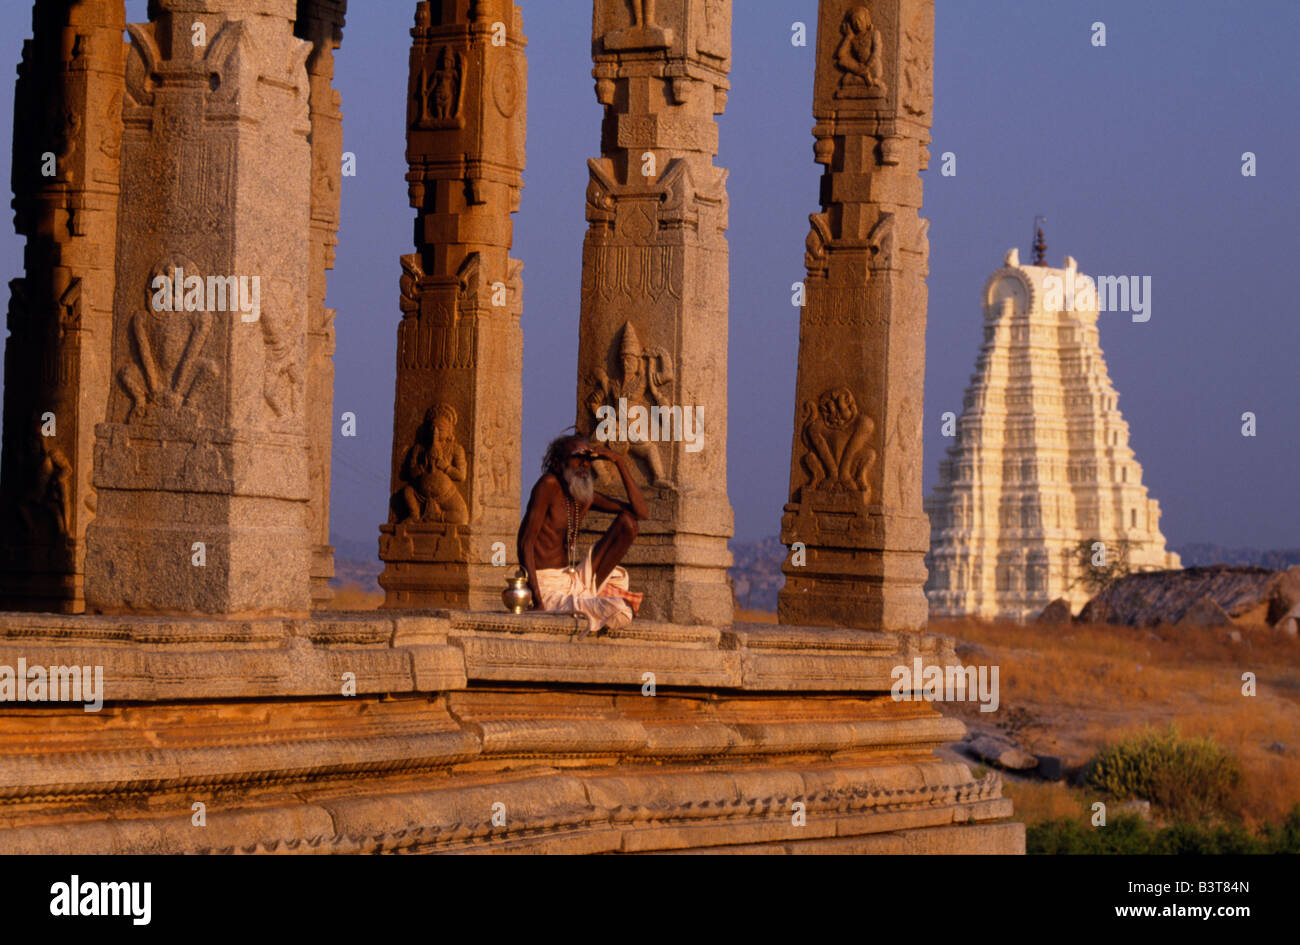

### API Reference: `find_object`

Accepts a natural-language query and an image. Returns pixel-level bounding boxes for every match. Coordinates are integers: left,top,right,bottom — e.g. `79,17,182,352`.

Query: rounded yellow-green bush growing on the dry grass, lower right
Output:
1084,725,1242,820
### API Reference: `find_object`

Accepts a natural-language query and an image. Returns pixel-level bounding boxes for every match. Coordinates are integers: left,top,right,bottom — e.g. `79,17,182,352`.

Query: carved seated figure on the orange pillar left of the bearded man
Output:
391,403,469,525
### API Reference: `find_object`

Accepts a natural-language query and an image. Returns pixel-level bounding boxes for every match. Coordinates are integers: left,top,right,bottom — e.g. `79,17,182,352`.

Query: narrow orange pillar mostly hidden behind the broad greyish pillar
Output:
295,0,347,607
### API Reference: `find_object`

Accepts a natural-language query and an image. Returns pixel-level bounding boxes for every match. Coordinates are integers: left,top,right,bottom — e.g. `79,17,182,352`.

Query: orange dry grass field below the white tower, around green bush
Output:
931,620,1300,825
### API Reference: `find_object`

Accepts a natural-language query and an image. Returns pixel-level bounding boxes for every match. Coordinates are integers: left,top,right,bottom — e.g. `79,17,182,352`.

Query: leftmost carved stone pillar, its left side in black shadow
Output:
0,0,126,612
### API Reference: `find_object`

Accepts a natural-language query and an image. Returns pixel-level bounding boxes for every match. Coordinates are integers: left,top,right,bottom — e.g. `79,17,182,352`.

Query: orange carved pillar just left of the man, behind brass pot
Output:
380,0,527,610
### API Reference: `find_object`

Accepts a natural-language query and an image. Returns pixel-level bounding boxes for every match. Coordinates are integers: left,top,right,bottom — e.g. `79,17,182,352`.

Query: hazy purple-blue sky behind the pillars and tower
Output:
0,0,1300,547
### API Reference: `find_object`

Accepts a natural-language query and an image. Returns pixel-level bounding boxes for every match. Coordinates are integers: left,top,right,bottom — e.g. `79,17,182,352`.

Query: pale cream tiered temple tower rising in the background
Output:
926,250,1180,617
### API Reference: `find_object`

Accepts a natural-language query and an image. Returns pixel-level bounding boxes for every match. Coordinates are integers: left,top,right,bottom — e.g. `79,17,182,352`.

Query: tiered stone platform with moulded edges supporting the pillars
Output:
0,611,1024,853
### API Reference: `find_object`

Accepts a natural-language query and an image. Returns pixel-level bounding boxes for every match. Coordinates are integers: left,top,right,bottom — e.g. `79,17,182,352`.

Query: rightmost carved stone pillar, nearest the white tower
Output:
779,0,935,630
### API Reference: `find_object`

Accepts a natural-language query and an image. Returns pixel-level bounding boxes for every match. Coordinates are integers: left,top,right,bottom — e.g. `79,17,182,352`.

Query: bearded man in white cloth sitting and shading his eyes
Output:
519,435,650,632
